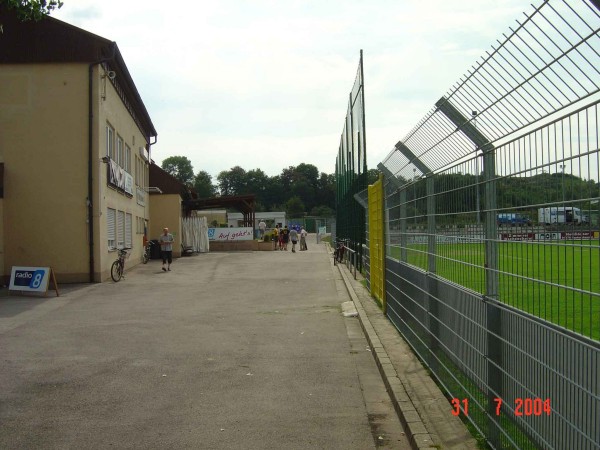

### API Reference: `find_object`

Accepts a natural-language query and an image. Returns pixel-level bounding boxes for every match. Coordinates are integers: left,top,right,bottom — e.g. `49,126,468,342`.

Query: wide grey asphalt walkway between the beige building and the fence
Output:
0,238,478,449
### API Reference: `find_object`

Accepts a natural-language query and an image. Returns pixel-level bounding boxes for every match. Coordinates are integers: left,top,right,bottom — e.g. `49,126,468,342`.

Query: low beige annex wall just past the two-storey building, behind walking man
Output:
148,194,182,258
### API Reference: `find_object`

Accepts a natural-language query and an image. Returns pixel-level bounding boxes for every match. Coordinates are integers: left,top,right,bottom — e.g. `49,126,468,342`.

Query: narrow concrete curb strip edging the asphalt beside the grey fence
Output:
338,258,439,450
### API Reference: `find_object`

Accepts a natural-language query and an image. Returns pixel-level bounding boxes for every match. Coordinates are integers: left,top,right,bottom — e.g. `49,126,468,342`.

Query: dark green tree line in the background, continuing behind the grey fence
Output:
162,156,600,222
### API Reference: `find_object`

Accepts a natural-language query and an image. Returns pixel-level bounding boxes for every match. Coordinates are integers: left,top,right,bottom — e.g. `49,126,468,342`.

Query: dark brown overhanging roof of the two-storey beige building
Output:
0,5,157,142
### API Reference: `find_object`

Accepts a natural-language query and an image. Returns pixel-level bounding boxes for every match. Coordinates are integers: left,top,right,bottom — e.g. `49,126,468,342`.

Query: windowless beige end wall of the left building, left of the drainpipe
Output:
0,64,88,282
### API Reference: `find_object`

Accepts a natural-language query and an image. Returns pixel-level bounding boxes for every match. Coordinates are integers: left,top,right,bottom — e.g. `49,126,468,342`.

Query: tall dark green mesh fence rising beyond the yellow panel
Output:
335,50,367,268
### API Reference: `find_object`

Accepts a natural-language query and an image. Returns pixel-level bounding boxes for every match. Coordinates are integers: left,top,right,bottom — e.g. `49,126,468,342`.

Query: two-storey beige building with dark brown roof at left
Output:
0,7,157,284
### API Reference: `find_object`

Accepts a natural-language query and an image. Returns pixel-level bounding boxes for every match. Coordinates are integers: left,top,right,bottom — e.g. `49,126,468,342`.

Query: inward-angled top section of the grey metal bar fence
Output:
383,0,600,180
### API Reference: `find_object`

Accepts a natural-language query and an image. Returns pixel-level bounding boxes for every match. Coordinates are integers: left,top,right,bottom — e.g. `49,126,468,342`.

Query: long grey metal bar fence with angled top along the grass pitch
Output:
360,0,600,449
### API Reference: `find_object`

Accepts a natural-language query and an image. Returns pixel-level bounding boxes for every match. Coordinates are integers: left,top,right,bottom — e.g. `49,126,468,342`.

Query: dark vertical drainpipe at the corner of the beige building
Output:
87,42,117,283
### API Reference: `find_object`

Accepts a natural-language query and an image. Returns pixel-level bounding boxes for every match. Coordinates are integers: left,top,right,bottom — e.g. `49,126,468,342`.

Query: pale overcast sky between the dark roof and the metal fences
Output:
52,0,528,182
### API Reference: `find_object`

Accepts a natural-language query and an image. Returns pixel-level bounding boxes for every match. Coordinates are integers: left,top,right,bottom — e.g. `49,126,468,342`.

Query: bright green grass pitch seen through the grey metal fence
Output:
391,239,600,340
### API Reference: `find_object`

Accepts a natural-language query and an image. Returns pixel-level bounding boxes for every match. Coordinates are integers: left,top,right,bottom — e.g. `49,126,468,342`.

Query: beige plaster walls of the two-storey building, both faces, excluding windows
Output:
0,63,149,283
